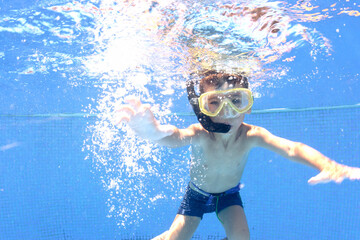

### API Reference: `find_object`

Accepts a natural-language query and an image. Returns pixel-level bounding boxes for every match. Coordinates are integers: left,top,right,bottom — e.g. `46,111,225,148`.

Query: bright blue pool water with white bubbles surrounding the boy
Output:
0,0,360,240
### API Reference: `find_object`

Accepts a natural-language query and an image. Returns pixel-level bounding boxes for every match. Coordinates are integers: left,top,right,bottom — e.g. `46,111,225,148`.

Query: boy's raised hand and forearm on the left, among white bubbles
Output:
117,97,174,141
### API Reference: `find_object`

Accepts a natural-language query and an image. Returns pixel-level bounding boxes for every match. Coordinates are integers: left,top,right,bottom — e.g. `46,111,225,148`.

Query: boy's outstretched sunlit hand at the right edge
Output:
308,163,360,185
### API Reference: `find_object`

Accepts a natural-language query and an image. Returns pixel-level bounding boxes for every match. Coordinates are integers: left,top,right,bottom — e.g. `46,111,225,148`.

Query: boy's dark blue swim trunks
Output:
178,182,243,219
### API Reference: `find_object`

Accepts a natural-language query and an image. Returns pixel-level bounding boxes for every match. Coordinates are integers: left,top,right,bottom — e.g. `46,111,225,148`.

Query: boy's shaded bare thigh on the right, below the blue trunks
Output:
218,205,250,240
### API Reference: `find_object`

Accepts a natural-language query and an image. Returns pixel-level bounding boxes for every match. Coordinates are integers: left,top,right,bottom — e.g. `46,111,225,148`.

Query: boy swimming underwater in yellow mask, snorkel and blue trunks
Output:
120,71,360,240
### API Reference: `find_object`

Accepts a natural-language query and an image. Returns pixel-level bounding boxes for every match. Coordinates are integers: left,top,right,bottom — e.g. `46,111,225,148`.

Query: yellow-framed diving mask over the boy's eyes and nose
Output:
199,88,253,118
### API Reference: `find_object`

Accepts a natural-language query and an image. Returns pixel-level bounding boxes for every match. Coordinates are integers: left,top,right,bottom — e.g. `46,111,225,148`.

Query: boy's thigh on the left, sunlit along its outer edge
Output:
166,214,201,240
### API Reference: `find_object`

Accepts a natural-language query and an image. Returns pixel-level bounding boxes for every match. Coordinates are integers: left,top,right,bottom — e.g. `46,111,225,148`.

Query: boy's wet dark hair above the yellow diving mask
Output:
199,70,249,94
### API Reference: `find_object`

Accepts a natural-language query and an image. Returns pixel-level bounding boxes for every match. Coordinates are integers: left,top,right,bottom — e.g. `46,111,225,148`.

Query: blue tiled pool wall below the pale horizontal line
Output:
0,107,360,240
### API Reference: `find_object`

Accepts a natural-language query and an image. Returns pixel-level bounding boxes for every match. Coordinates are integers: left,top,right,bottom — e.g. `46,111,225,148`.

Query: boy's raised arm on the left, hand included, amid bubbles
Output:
118,97,195,147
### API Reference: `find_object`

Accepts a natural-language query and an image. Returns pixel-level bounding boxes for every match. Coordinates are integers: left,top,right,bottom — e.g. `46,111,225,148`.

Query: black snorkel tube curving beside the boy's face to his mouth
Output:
186,80,231,133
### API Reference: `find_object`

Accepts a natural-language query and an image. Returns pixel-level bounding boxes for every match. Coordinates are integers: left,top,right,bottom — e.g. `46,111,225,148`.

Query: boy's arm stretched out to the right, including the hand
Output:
250,127,360,184
